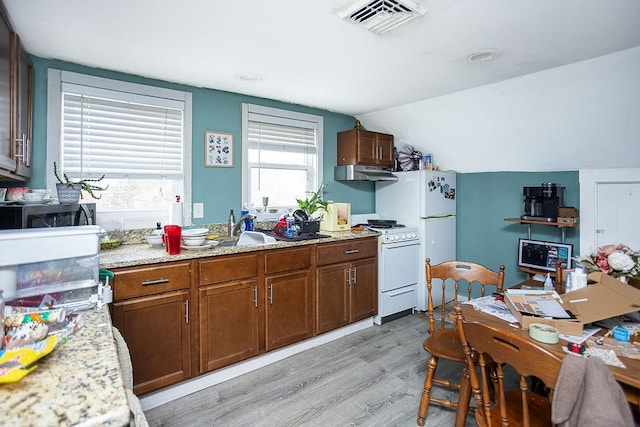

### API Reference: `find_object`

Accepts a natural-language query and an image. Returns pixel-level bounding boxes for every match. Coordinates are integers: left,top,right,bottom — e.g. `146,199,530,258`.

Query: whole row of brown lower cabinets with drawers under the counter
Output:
111,238,378,395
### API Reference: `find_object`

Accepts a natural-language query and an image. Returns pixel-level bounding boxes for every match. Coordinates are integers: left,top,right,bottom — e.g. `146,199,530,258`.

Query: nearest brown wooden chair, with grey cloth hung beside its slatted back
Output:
454,306,562,427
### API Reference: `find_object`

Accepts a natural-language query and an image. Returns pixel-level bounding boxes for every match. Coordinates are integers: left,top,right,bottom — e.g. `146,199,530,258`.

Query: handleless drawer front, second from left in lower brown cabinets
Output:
198,254,258,285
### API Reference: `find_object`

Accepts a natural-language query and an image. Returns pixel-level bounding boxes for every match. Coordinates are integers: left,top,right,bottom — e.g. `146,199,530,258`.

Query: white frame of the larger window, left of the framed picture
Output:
46,69,192,229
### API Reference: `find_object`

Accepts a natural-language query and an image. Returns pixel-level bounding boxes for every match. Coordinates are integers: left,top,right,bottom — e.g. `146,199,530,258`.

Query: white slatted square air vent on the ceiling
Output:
337,0,427,35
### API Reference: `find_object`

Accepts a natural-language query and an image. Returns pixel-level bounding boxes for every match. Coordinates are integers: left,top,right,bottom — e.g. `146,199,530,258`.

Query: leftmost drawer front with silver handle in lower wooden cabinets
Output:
114,262,191,301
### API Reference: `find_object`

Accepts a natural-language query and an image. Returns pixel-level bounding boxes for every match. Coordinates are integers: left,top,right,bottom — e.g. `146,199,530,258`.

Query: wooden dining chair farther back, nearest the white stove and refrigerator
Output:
417,258,504,426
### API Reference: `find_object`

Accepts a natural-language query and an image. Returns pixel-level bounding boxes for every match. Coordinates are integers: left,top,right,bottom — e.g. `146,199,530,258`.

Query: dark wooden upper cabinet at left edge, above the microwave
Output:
0,3,33,181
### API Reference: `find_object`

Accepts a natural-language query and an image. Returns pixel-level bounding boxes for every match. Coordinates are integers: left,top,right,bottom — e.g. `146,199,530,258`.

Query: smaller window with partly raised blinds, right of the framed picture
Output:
243,104,322,213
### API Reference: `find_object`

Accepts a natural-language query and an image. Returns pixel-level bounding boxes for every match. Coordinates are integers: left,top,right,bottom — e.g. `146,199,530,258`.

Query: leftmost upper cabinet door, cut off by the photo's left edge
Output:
0,7,16,174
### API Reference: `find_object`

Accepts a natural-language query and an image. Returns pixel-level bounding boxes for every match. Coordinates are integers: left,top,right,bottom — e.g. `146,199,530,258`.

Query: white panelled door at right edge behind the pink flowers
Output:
580,169,640,256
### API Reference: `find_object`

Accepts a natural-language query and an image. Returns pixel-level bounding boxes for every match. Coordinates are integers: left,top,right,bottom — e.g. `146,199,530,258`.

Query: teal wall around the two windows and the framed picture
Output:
30,57,375,224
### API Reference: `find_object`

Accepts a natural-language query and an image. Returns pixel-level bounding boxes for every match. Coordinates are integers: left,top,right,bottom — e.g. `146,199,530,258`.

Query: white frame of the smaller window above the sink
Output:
241,103,324,220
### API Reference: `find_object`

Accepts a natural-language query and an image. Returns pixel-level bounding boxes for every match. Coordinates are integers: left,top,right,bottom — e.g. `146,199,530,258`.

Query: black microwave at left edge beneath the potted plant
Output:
0,203,96,230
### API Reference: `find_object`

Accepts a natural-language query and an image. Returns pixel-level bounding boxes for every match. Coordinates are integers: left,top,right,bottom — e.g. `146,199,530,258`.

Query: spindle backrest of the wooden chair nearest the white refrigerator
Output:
426,258,504,332
